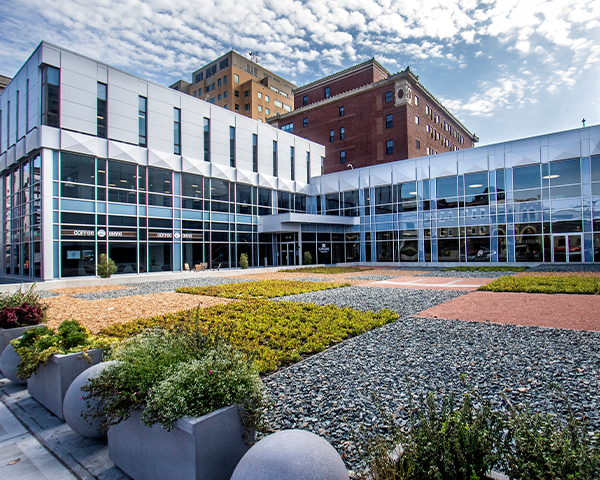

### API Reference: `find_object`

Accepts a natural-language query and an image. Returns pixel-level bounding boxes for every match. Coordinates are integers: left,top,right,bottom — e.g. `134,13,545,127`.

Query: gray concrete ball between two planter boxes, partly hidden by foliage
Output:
63,362,117,438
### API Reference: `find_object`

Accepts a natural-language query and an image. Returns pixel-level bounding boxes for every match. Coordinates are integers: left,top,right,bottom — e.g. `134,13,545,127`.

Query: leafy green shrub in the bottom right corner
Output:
502,388,600,480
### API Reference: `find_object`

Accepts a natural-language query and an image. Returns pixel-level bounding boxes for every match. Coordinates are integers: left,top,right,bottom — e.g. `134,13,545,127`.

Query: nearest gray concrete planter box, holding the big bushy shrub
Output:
108,405,254,480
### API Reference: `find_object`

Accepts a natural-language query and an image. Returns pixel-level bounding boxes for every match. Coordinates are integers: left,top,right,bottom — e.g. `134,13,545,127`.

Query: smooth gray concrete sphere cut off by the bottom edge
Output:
231,430,349,480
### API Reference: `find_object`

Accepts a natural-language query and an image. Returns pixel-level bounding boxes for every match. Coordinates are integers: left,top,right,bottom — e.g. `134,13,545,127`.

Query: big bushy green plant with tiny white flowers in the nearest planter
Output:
83,329,262,430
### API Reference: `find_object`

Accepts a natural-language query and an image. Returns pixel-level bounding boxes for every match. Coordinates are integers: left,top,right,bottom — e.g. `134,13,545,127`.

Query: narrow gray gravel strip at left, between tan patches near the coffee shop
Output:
71,277,254,300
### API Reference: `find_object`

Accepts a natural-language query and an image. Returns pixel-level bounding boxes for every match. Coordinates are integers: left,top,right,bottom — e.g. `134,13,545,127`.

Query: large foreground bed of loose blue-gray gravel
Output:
264,317,600,471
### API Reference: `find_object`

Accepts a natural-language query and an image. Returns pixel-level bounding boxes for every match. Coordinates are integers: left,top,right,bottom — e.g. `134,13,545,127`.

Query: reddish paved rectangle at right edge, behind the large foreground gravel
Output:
414,292,600,331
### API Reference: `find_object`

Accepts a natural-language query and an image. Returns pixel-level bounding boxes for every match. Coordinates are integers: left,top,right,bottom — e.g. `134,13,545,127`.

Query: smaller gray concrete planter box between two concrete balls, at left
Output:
27,348,102,420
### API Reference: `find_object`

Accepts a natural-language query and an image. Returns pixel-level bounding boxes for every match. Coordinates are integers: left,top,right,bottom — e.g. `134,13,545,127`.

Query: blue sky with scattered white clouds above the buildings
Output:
0,0,600,145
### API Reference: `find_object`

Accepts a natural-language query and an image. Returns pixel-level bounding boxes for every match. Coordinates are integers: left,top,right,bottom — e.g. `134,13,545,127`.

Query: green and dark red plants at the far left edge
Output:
0,284,48,328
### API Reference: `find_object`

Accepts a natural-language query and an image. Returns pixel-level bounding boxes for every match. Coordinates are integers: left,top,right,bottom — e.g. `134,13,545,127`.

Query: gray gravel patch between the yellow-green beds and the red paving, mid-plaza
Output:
273,287,467,316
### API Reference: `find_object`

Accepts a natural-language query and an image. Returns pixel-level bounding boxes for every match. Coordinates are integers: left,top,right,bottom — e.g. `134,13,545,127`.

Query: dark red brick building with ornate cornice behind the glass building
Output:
267,59,479,173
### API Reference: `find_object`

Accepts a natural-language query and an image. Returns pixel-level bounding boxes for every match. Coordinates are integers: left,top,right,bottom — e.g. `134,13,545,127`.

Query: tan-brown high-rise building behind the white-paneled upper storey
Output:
171,50,296,122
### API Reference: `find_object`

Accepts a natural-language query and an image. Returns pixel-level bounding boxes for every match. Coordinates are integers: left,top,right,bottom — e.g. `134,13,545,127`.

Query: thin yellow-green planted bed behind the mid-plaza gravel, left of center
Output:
176,280,350,300
